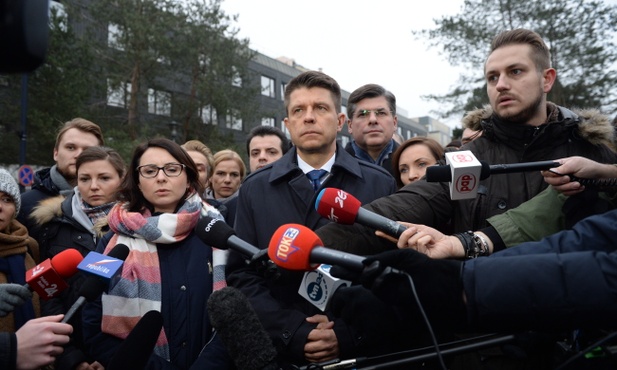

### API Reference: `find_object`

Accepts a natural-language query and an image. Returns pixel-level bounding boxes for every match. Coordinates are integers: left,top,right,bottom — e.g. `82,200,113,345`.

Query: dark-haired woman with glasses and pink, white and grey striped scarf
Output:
83,139,231,369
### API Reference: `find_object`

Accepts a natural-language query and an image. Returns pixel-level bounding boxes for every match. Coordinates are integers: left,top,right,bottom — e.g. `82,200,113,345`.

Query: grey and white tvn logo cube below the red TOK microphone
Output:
298,264,351,311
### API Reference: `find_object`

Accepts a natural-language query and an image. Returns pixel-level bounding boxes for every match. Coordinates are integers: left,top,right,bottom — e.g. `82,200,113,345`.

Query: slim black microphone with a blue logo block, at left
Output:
61,244,129,322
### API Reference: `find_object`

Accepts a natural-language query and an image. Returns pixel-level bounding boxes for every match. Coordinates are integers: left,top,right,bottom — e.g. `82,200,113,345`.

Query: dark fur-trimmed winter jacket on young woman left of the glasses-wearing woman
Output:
32,193,102,370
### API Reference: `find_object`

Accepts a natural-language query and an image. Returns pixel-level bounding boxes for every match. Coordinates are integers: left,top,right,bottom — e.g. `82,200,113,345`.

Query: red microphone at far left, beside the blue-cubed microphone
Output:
24,248,84,300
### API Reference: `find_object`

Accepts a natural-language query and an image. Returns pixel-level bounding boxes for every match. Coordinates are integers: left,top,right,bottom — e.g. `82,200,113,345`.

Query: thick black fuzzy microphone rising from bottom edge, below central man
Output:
207,287,279,370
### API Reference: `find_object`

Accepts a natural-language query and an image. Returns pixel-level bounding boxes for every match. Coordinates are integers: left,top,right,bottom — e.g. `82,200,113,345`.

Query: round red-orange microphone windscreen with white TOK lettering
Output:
268,224,323,271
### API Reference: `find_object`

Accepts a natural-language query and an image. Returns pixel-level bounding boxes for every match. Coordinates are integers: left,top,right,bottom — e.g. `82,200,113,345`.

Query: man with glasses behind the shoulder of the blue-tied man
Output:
345,84,399,176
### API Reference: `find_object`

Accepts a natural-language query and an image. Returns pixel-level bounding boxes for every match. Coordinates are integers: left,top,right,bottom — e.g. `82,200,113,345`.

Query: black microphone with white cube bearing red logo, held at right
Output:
426,150,561,200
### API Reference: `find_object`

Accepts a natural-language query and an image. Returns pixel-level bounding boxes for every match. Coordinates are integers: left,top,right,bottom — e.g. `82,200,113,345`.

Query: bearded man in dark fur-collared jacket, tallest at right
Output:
317,29,617,369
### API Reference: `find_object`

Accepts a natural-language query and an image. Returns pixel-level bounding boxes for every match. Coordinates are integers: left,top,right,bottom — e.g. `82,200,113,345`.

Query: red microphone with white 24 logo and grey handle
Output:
315,188,407,239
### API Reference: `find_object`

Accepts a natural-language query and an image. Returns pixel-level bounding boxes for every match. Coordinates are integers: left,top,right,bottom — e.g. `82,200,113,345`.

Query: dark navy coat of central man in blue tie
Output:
227,145,396,363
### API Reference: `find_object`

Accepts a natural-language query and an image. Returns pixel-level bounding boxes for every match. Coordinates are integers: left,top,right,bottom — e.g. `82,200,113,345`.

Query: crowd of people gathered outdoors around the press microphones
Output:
0,29,617,370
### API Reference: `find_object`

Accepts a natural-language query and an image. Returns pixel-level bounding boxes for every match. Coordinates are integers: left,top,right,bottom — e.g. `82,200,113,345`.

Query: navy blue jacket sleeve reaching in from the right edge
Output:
463,210,617,330
